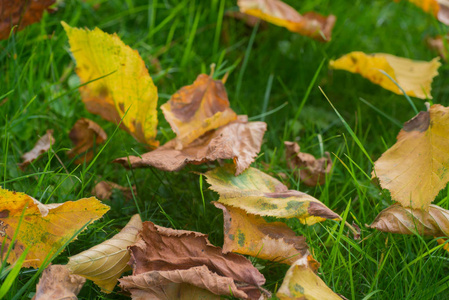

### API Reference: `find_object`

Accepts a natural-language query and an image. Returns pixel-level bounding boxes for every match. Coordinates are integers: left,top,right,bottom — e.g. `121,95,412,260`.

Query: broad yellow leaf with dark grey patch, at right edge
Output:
372,104,449,209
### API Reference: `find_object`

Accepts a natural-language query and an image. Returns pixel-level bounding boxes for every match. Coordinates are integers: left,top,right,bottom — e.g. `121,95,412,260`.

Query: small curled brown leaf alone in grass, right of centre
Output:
284,142,332,186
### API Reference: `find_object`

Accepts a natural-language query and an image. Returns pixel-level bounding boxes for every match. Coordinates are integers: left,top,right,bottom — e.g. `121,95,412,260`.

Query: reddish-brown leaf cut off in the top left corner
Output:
0,0,56,40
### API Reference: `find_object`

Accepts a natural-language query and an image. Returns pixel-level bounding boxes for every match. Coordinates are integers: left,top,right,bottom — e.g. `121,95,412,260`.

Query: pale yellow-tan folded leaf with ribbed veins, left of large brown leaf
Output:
67,215,142,293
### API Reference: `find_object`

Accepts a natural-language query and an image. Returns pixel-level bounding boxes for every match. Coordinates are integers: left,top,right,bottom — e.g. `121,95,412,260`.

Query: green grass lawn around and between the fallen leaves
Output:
0,0,449,300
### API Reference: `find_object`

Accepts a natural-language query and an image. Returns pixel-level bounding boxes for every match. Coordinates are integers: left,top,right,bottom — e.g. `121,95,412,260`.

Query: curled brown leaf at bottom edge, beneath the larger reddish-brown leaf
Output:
119,266,248,300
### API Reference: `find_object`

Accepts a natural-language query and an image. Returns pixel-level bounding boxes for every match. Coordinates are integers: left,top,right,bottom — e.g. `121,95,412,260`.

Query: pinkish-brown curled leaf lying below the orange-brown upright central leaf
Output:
114,116,267,175
